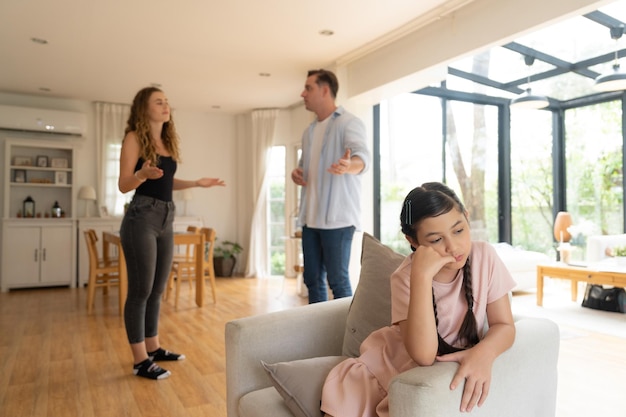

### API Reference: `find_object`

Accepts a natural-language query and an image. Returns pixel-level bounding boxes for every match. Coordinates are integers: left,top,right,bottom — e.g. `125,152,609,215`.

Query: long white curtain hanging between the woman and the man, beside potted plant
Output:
246,109,279,278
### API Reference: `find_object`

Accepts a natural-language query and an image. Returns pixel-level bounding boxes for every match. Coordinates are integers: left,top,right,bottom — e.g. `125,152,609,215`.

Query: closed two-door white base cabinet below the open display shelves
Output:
2,219,76,292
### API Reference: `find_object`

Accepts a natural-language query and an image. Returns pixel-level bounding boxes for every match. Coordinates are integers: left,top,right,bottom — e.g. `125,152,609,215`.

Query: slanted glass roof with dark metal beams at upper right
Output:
436,0,626,104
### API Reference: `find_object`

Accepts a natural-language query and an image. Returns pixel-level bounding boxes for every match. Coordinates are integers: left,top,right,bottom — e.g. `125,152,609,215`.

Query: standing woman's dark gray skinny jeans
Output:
120,195,175,344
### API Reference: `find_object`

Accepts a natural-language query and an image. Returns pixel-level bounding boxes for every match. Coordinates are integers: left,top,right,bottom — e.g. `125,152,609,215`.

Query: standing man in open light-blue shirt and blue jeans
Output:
291,69,370,304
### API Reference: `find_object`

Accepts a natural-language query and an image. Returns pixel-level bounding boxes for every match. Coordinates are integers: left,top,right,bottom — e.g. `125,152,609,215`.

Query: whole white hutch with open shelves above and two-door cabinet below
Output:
1,139,76,291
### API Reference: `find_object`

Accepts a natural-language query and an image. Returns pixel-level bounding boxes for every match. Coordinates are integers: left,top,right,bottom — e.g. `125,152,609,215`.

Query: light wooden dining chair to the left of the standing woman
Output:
84,229,119,314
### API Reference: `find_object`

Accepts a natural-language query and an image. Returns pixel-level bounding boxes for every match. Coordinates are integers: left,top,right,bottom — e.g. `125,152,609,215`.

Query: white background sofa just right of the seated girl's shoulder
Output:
492,242,554,292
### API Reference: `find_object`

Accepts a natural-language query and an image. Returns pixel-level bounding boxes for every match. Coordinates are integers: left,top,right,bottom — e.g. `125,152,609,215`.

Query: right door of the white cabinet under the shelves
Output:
40,226,74,285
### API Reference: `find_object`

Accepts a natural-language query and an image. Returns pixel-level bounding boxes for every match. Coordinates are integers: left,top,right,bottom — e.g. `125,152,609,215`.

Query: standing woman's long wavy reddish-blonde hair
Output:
124,87,180,166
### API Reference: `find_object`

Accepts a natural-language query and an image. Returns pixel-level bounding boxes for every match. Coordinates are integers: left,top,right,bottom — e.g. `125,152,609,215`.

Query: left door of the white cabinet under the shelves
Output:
2,227,41,291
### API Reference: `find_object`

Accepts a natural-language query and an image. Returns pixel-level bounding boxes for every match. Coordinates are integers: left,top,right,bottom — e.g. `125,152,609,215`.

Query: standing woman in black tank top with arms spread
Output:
118,87,225,379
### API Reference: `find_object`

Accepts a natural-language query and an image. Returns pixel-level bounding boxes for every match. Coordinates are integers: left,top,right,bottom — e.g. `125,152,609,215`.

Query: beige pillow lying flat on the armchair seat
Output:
261,356,346,417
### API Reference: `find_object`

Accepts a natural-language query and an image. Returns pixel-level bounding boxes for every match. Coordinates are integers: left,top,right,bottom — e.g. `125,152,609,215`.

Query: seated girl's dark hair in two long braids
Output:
400,182,478,355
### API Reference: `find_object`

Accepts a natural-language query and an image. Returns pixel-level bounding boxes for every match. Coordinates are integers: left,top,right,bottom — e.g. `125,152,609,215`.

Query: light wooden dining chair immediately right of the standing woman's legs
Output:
165,230,205,308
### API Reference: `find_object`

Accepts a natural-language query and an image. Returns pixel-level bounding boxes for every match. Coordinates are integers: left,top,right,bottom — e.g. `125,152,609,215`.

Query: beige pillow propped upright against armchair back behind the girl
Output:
342,233,405,358
